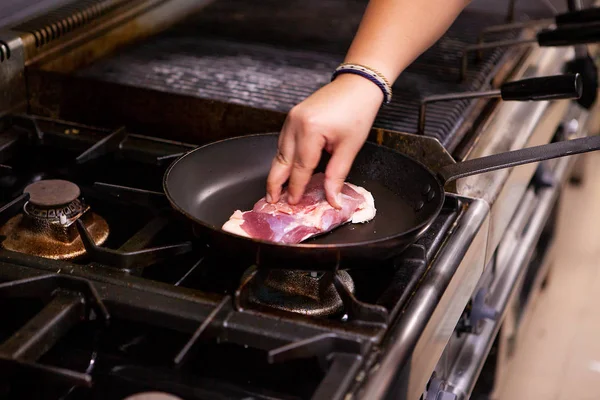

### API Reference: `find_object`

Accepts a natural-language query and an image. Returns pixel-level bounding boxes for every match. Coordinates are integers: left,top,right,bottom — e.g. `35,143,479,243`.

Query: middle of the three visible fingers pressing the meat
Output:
288,132,325,204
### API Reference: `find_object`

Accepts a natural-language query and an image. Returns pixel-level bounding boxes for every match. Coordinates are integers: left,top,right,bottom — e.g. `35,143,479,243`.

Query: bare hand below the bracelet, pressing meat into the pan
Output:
267,74,383,208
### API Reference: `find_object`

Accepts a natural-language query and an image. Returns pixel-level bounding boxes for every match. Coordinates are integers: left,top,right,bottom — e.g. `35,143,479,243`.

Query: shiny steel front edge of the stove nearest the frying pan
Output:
355,195,490,399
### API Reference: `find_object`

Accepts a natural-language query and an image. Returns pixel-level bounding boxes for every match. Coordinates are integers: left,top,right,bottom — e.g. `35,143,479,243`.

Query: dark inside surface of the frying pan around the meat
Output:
165,134,443,245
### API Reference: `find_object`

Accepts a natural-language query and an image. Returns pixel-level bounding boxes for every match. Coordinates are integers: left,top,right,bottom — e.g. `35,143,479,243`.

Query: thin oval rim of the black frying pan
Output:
163,132,446,250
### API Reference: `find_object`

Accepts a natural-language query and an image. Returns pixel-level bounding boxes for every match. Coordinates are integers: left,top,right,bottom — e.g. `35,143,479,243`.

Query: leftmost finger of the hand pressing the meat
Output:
266,121,295,203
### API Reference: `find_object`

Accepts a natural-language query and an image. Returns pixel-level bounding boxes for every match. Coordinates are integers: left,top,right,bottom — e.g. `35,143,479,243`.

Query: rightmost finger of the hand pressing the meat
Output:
325,142,360,209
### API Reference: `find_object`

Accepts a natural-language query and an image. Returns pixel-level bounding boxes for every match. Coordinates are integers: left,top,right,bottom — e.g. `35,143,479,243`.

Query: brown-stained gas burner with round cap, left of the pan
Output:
0,180,109,260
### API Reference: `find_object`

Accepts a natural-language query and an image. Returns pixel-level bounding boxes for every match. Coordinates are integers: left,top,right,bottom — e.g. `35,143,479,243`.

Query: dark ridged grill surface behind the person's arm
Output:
79,0,560,147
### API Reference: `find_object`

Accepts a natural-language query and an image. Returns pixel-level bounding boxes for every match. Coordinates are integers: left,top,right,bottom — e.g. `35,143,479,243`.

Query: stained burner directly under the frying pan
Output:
242,268,354,317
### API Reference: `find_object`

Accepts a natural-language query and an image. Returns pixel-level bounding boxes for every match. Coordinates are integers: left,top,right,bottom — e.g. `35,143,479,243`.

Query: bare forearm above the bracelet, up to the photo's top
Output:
345,0,469,82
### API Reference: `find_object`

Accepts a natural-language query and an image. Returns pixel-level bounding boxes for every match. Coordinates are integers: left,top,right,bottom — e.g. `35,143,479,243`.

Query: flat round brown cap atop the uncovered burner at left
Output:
23,179,81,207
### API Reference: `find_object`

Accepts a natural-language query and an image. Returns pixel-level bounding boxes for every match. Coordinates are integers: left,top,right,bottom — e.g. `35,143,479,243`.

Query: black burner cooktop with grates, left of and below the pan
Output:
0,116,467,399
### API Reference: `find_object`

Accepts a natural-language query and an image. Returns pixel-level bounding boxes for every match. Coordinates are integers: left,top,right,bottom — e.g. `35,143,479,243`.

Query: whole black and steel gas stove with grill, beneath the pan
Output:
0,0,597,400
